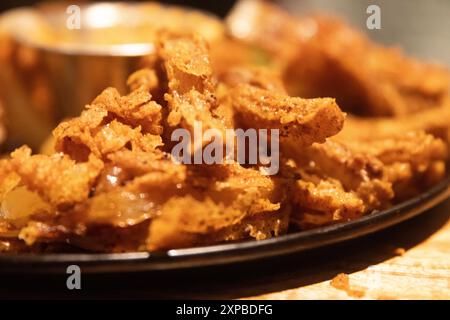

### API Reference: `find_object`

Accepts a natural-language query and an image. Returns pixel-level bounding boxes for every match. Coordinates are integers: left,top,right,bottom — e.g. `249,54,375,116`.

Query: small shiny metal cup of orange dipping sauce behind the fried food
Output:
0,2,221,149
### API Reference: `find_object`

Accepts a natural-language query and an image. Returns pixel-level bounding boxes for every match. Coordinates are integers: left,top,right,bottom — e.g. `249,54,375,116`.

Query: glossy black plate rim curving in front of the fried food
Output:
0,177,450,274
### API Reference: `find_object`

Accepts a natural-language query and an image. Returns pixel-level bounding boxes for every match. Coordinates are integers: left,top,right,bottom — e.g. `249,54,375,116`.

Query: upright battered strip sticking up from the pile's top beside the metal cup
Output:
157,35,229,141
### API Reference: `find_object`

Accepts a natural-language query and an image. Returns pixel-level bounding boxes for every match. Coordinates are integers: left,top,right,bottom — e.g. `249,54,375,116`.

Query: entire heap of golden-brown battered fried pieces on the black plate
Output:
0,12,450,252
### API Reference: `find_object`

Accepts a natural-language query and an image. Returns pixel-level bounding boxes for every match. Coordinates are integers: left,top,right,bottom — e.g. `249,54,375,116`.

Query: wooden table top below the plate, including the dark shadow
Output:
0,201,450,299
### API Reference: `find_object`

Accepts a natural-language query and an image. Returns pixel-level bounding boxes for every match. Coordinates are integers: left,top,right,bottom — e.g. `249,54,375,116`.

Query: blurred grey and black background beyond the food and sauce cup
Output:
0,0,450,66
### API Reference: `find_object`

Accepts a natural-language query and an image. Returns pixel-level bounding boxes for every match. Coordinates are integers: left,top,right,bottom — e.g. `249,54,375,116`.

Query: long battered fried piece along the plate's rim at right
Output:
292,132,448,228
